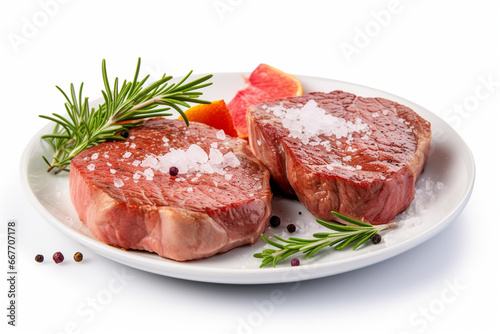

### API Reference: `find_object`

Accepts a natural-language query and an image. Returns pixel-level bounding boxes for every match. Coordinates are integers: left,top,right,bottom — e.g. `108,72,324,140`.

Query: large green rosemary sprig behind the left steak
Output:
39,58,212,174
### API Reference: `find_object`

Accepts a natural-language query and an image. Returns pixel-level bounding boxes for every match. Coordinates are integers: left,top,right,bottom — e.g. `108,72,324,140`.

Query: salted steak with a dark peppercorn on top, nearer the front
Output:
70,119,272,261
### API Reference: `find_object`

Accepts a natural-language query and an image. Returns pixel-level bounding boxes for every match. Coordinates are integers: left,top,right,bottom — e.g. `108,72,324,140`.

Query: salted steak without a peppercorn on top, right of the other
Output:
247,91,431,224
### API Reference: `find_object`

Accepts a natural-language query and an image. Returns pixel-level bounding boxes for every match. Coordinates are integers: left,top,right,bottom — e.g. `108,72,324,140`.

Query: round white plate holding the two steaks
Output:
21,73,475,284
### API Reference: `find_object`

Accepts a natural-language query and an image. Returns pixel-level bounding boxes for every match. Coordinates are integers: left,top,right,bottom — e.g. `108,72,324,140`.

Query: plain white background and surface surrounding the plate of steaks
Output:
0,0,500,334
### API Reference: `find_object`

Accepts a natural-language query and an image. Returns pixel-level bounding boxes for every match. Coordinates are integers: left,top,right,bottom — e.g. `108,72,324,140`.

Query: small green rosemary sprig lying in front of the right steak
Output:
253,211,397,268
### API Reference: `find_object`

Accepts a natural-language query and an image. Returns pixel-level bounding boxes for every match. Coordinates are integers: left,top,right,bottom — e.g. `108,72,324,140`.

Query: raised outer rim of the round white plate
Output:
19,72,476,284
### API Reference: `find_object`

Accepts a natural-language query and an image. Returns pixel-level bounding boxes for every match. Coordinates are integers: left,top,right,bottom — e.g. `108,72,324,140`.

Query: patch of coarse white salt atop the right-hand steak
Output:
266,100,371,145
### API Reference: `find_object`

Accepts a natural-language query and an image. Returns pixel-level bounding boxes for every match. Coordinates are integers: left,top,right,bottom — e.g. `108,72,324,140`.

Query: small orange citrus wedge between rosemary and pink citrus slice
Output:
179,100,238,137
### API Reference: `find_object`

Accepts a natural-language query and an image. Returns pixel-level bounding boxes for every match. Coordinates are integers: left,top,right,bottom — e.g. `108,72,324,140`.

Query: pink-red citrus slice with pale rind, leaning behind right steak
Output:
227,64,302,138
